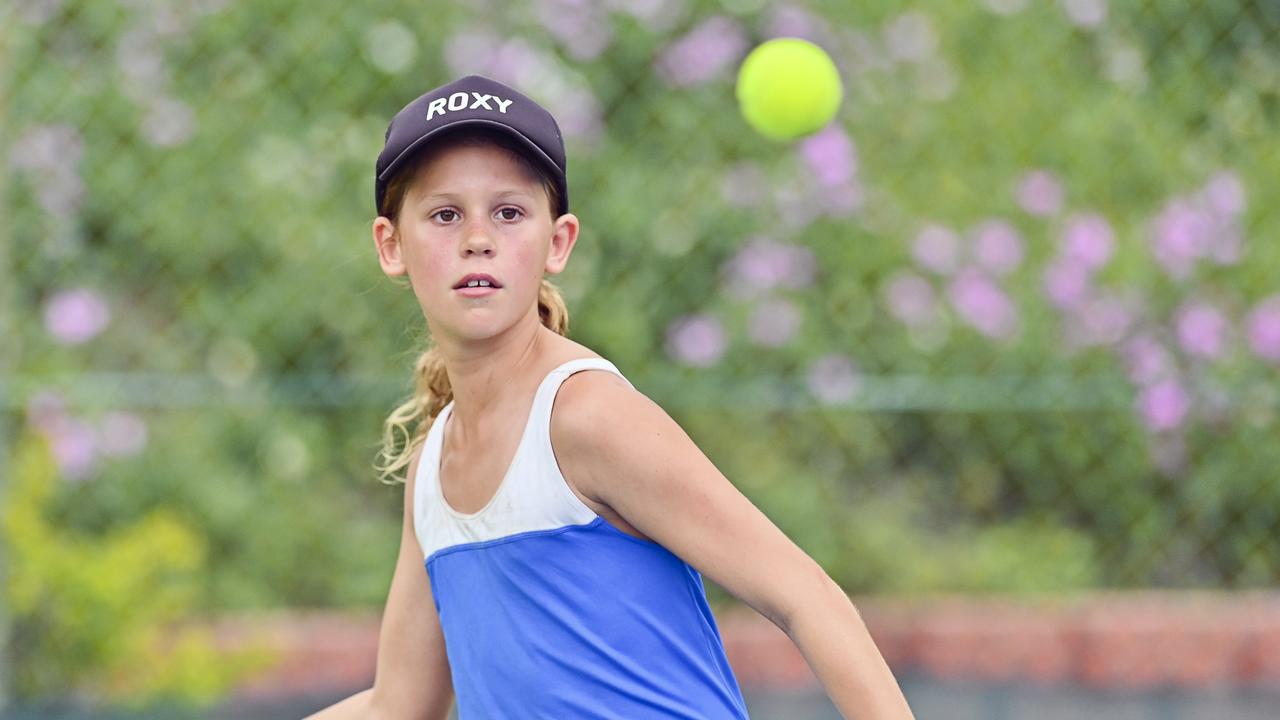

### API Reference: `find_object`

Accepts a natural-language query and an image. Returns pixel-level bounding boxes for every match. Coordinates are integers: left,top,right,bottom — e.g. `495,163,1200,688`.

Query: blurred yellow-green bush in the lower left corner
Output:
0,433,271,706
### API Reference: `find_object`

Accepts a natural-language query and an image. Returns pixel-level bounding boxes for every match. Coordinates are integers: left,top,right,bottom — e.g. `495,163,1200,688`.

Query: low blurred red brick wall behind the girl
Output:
202,592,1280,697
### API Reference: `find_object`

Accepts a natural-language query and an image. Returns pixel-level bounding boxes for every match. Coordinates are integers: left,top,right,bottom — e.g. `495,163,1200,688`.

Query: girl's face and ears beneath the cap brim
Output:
374,146,577,341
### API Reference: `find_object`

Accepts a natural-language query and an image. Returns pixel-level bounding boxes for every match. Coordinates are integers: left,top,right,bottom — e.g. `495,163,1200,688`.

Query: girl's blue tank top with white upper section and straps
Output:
413,357,748,720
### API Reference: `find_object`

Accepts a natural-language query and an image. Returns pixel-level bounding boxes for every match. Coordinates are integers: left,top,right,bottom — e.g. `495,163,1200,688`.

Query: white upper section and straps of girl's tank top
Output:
413,357,635,560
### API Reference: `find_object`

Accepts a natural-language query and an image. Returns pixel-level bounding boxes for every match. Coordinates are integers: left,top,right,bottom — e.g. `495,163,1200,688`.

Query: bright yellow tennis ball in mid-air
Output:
735,37,845,141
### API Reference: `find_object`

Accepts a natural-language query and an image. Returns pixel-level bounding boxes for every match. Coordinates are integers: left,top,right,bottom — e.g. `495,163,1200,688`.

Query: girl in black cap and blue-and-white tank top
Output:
305,76,911,720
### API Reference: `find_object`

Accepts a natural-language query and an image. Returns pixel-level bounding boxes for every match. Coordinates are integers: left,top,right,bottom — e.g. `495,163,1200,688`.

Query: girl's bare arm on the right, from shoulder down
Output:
552,372,914,720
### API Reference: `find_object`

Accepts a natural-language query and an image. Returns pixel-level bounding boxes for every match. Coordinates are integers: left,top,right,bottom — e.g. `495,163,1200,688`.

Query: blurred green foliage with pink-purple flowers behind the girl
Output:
0,0,1280,698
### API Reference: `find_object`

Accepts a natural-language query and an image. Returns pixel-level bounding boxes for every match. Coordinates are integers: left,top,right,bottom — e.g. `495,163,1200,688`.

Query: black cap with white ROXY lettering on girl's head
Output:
374,76,568,215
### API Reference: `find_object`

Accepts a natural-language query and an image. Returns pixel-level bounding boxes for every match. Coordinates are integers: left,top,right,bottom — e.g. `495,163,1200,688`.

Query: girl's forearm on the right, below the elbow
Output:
783,582,915,720
